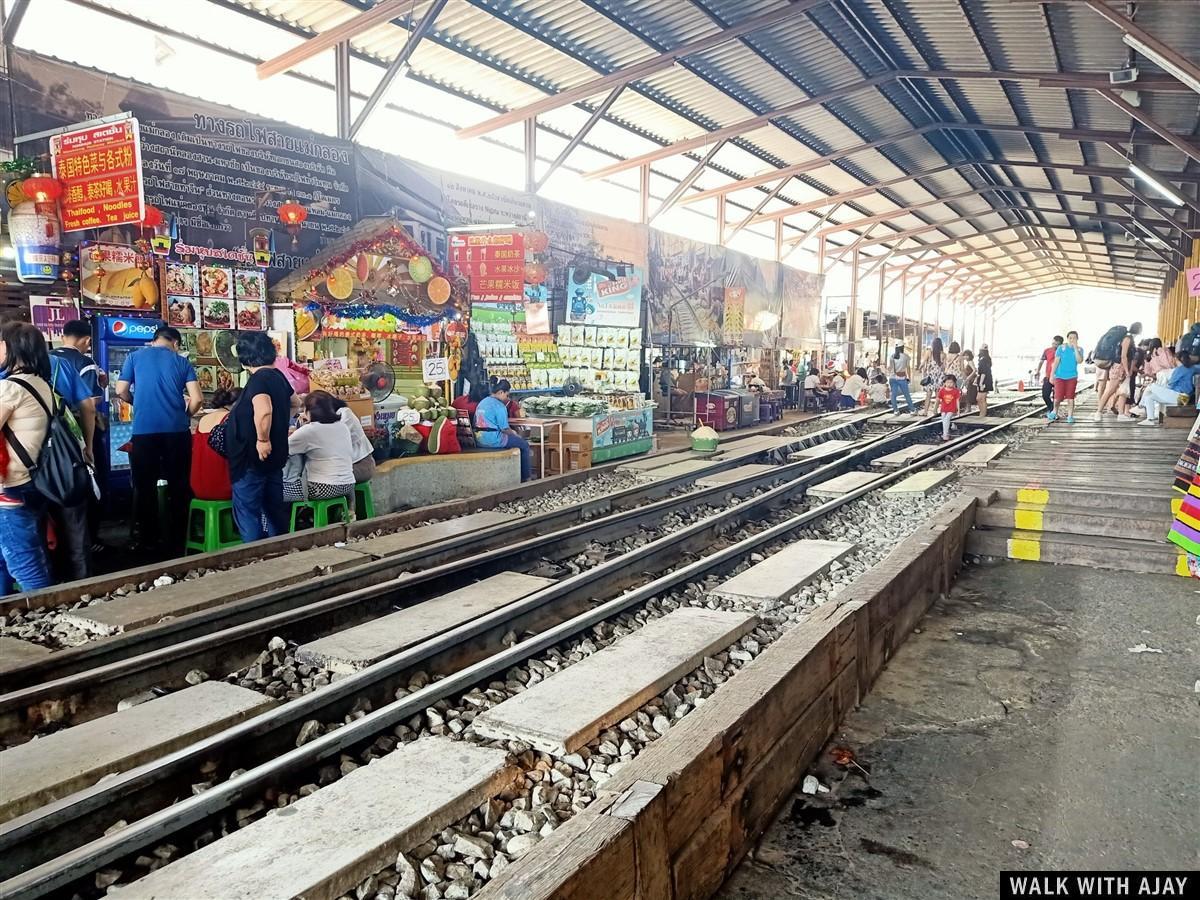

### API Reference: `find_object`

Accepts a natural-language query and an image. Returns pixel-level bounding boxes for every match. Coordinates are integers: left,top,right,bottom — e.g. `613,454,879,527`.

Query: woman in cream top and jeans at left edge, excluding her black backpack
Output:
0,322,53,596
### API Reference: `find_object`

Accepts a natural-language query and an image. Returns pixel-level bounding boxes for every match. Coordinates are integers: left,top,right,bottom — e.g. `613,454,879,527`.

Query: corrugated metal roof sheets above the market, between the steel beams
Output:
147,0,1200,292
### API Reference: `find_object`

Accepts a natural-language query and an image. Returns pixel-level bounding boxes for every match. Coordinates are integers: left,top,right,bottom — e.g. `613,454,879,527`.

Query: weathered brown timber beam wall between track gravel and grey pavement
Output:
478,492,986,900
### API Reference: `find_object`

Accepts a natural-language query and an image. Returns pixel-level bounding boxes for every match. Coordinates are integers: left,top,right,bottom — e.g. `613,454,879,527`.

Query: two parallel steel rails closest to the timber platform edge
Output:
0,409,1040,900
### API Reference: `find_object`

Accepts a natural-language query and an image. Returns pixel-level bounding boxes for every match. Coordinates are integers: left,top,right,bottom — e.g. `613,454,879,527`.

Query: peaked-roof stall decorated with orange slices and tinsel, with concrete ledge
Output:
270,211,520,512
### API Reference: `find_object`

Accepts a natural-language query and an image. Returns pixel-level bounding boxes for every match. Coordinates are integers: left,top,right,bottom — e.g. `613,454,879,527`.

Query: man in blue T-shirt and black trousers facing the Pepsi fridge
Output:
116,325,204,556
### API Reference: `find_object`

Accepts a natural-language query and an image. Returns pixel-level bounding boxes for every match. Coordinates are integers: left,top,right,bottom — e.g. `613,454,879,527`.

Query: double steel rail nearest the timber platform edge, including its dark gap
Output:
0,413,1034,896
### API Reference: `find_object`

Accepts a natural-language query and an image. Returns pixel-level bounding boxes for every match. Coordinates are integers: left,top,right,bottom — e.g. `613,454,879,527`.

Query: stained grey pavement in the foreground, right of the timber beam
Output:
719,563,1200,900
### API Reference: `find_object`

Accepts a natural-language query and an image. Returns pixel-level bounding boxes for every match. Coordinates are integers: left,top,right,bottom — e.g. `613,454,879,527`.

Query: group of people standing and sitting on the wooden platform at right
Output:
1034,322,1200,427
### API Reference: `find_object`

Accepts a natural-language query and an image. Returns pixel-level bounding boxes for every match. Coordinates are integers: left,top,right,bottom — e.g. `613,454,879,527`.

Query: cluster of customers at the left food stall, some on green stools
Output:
0,322,374,595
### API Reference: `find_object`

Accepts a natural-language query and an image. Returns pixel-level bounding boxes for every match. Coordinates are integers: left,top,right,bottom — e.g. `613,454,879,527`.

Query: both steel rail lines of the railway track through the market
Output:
0,398,1033,898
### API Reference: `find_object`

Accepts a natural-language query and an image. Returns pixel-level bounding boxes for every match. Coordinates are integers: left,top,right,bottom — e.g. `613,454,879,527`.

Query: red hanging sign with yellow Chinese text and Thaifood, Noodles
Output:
50,119,144,232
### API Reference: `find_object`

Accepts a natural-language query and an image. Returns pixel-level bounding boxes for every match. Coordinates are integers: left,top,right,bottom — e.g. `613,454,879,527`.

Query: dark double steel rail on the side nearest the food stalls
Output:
0,408,998,743
